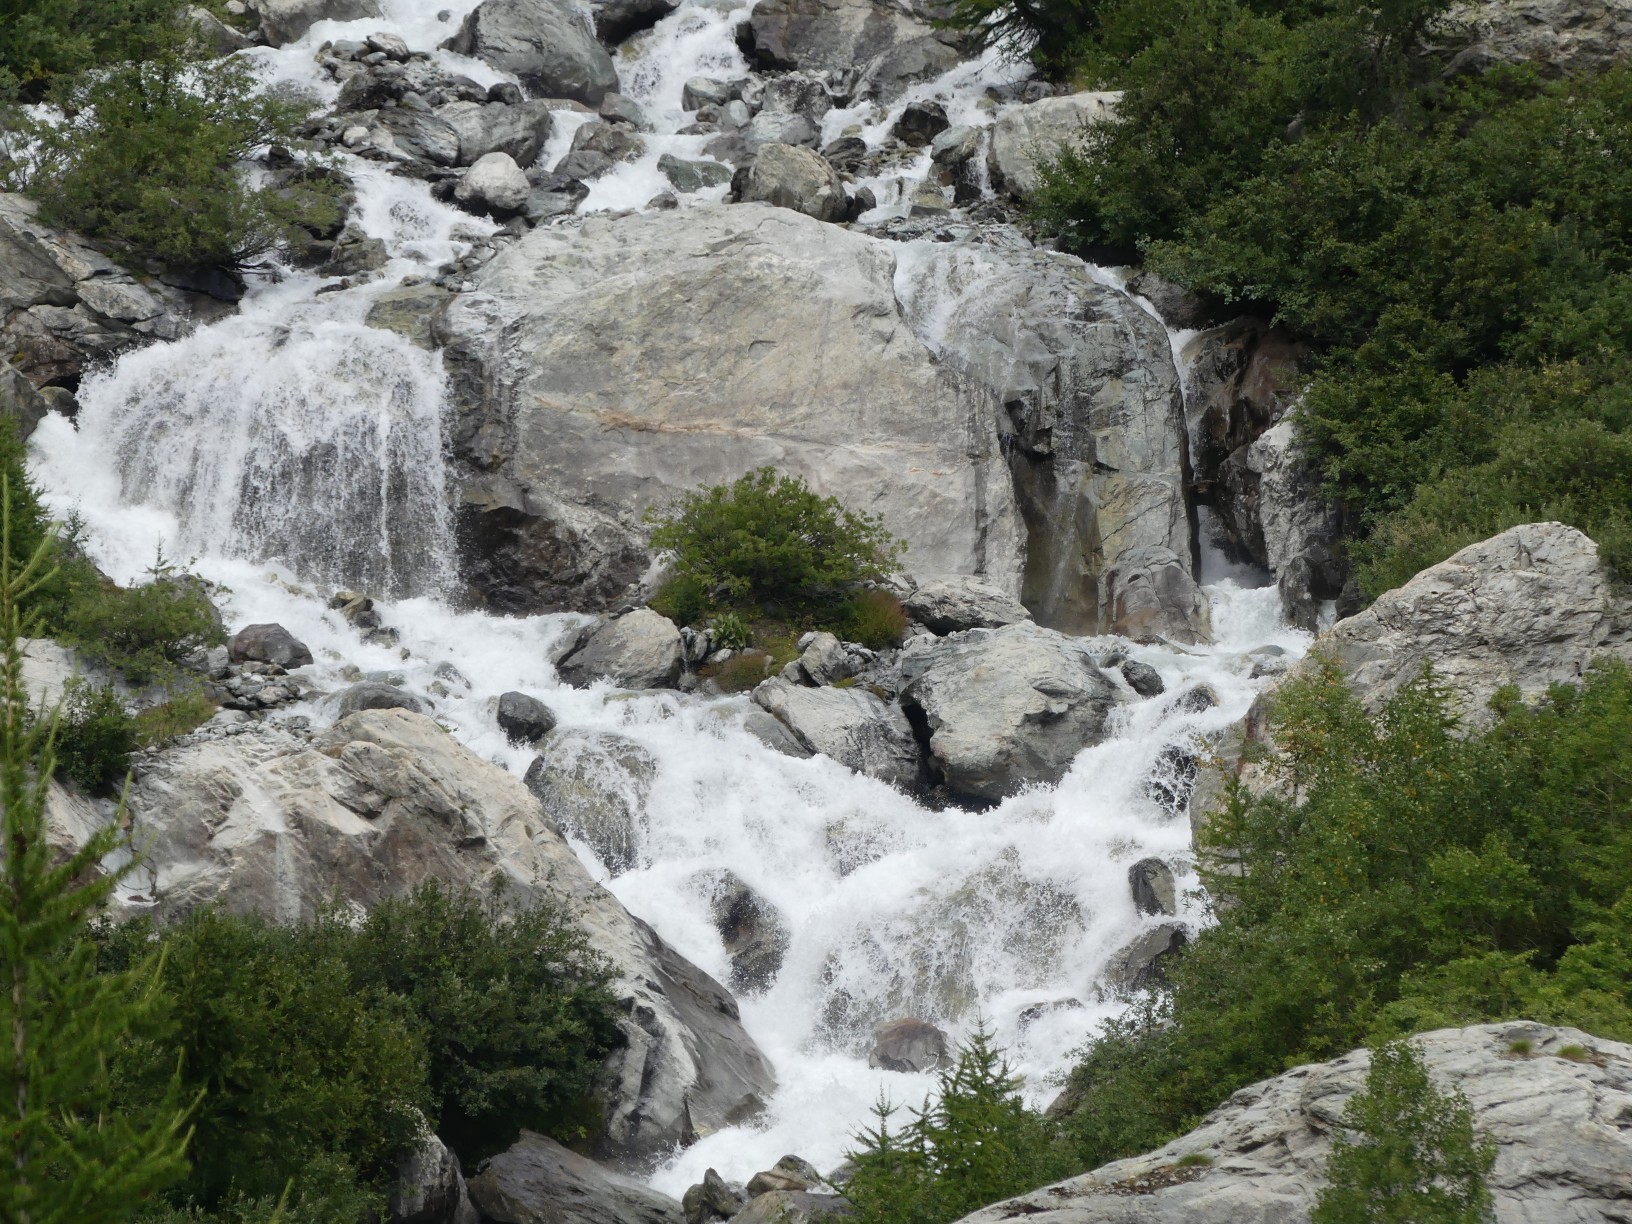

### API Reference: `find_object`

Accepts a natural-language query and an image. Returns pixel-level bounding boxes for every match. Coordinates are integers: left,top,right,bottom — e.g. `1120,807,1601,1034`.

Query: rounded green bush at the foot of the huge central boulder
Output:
651,467,906,620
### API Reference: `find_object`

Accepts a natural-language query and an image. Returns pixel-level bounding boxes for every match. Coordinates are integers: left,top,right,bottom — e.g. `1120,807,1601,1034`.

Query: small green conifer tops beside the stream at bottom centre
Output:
844,1027,1069,1224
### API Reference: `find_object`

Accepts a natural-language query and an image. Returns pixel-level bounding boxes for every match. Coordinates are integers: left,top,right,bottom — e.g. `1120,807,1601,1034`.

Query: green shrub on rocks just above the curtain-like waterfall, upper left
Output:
13,46,338,268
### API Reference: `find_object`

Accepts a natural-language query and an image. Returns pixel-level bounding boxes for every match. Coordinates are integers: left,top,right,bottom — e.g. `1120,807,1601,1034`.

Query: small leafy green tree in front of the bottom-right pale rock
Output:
1310,1041,1497,1224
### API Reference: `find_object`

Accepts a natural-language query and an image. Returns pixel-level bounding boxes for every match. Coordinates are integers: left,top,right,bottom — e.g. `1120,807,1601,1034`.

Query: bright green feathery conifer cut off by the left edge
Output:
0,489,188,1224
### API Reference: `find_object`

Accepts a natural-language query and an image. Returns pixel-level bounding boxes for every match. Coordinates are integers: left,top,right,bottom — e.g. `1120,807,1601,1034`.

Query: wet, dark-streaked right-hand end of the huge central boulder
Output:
898,242,1208,641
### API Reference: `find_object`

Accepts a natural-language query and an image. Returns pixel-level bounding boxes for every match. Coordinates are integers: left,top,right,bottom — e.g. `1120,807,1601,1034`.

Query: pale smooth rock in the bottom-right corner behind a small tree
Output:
963,1020,1632,1224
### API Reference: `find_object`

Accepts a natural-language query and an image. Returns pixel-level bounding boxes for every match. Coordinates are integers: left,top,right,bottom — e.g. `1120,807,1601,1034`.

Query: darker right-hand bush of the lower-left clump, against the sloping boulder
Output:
346,883,620,1162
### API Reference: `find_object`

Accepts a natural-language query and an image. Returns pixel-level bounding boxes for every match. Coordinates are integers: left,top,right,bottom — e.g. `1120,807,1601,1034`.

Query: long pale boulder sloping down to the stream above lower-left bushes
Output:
97,710,774,1160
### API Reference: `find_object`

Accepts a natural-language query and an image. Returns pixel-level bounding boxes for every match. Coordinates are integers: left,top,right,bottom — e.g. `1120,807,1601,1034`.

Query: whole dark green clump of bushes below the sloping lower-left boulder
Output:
98,885,619,1224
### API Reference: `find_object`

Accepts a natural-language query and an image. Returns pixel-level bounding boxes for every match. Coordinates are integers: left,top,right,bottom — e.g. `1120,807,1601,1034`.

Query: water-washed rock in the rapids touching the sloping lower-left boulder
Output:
524,730,658,875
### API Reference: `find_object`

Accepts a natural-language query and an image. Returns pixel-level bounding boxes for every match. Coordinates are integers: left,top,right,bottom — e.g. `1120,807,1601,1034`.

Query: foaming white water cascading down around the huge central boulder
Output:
25,0,1307,1195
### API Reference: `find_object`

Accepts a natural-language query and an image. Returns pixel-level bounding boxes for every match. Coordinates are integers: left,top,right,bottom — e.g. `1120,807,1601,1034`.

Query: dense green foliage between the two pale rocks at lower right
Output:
1069,664,1632,1167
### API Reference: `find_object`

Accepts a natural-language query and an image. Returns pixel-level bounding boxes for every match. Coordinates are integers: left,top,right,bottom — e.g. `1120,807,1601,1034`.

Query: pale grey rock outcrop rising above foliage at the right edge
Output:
1314,522,1632,726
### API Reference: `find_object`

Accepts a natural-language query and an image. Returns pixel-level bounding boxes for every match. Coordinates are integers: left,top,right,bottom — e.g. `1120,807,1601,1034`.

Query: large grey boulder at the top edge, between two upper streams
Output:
442,0,619,106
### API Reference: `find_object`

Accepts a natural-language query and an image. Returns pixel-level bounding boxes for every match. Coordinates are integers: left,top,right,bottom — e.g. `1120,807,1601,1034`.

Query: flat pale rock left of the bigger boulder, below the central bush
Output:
754,676,919,787
